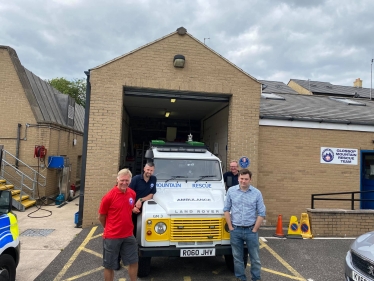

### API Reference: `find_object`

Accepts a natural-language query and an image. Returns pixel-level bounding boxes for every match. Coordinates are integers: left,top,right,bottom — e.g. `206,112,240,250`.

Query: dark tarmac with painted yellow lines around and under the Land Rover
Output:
35,226,352,281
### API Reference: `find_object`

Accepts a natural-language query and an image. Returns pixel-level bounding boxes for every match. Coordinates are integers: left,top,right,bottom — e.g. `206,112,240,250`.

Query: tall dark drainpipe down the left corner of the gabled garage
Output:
76,70,91,227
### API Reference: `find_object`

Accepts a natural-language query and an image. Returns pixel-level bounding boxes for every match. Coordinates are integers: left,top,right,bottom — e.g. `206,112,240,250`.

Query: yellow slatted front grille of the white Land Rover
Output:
170,219,222,242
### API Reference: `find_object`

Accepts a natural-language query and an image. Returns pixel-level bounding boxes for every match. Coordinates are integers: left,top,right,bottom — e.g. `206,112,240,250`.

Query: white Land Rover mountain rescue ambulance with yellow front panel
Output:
136,141,247,277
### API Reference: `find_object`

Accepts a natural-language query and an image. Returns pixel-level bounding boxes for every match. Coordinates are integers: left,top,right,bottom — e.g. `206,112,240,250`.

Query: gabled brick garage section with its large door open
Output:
79,27,261,227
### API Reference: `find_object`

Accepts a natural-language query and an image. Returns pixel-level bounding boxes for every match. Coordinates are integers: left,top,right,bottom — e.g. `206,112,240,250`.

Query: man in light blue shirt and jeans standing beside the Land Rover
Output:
223,169,266,281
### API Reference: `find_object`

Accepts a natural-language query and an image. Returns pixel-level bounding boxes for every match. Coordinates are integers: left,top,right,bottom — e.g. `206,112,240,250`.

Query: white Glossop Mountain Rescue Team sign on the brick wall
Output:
320,147,358,165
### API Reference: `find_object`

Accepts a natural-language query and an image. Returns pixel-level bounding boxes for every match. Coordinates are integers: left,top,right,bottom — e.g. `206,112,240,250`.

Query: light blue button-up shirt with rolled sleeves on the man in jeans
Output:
223,185,266,226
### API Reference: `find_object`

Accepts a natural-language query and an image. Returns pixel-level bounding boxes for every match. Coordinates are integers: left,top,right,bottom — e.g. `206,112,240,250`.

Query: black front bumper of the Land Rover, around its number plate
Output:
139,245,232,257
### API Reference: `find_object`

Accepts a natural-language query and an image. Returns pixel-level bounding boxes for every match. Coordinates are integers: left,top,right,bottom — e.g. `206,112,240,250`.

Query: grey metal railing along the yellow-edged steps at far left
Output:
0,149,46,201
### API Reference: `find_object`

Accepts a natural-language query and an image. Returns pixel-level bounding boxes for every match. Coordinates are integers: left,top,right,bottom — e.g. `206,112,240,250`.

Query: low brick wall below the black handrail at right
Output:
307,209,374,237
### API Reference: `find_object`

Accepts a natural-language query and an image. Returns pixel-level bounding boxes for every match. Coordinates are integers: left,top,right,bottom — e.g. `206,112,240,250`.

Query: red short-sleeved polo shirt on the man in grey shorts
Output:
99,186,136,239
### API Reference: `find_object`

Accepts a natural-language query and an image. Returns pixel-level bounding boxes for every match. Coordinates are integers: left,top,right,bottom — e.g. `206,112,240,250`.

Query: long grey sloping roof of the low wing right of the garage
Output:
260,94,374,125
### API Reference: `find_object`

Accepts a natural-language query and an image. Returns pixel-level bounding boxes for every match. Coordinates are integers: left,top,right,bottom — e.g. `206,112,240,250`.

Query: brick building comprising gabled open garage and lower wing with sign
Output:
82,28,374,227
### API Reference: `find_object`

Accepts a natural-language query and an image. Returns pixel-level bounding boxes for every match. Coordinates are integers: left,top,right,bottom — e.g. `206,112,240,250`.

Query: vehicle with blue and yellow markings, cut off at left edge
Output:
0,190,20,281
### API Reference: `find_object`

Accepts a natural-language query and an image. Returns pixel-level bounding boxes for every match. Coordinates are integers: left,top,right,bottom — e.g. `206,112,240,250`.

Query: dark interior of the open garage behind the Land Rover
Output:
120,87,231,174
